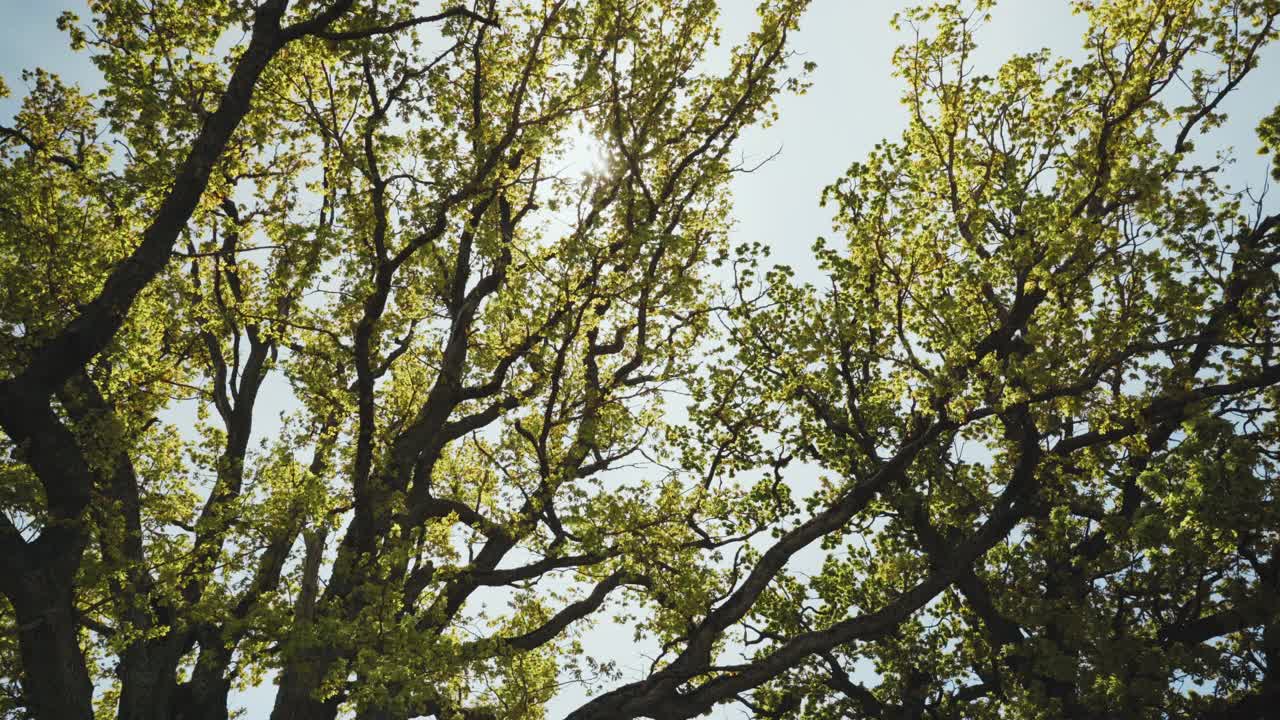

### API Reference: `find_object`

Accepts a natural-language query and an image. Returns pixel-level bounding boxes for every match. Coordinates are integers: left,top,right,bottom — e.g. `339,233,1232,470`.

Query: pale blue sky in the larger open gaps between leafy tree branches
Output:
0,0,1280,720
